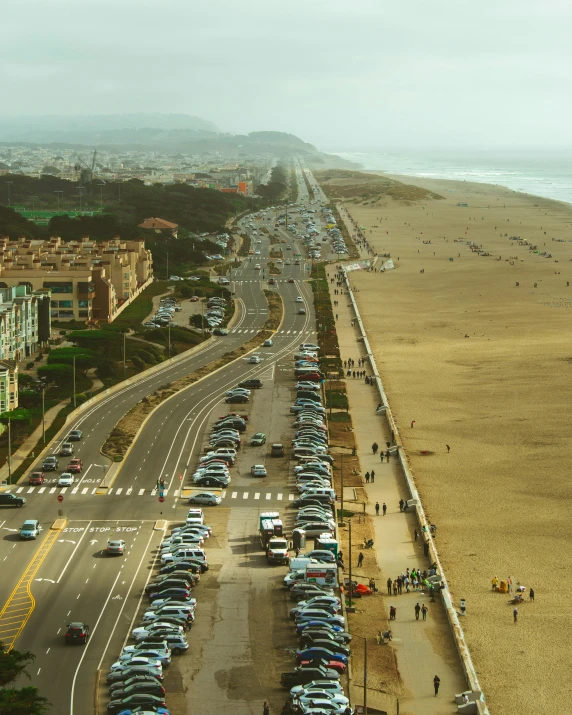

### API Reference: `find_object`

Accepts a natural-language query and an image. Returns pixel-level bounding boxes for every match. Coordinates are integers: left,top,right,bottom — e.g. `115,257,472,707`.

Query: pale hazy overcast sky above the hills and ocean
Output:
0,0,572,150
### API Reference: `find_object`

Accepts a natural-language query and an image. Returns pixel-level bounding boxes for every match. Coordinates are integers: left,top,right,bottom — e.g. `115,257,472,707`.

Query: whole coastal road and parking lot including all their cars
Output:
0,162,351,715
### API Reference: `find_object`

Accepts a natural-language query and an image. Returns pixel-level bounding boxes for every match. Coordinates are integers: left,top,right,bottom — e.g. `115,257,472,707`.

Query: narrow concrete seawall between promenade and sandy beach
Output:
343,270,489,715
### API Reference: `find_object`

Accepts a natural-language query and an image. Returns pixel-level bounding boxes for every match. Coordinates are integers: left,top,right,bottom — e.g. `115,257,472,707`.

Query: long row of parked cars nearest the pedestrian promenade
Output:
280,343,352,715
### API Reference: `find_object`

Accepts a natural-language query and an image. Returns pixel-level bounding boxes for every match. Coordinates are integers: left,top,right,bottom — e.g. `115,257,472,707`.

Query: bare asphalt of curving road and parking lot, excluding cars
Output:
0,165,326,715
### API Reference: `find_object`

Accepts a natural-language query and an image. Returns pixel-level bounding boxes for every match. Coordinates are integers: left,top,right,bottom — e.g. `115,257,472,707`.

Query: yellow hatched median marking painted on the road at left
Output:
0,530,61,651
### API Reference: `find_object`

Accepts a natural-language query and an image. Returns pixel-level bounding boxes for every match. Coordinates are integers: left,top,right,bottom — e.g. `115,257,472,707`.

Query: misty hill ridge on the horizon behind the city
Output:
0,113,358,168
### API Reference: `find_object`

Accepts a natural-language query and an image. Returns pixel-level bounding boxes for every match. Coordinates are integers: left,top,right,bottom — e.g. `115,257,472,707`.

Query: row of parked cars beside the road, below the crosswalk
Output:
102,509,212,715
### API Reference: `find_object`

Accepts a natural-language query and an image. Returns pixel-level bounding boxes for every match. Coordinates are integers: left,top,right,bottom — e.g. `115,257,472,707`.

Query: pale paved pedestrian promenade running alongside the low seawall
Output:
327,266,466,715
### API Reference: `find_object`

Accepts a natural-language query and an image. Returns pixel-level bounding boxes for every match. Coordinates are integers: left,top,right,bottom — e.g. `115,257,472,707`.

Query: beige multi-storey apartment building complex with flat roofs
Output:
0,236,153,323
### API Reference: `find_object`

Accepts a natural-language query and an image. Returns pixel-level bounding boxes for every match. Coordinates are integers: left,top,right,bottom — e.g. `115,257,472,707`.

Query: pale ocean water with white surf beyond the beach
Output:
330,149,572,203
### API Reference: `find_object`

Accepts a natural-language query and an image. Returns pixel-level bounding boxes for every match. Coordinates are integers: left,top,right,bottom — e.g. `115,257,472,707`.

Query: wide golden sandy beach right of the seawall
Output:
323,172,572,715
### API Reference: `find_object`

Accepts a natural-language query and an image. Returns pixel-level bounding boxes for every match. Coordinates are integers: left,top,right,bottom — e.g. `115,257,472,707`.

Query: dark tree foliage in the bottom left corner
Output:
0,641,49,715
